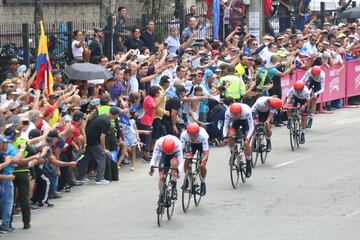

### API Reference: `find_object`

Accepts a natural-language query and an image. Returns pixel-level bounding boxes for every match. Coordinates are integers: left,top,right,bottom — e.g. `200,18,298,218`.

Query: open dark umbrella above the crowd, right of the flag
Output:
64,63,112,80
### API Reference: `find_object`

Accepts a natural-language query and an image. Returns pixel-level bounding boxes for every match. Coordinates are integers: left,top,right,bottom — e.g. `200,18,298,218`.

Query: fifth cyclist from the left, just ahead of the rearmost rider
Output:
283,80,310,144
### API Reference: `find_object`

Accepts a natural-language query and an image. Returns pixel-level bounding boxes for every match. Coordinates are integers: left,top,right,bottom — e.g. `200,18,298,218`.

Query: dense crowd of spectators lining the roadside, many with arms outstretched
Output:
0,1,360,232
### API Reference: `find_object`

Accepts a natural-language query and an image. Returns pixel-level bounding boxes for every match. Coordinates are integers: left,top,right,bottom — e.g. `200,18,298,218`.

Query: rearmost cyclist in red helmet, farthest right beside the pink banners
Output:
301,66,325,116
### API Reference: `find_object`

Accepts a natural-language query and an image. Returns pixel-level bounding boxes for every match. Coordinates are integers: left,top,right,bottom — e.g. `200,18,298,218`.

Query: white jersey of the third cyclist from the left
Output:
223,103,254,139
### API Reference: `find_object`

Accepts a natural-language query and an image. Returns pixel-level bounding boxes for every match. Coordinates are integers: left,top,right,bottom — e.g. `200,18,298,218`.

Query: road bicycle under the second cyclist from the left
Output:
181,151,201,213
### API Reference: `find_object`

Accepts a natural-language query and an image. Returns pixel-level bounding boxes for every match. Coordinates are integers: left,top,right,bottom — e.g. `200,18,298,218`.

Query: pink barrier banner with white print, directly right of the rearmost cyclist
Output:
322,65,346,102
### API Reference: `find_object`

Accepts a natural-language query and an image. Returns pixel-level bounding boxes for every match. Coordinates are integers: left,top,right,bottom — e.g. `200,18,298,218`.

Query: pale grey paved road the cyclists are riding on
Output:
1,109,360,240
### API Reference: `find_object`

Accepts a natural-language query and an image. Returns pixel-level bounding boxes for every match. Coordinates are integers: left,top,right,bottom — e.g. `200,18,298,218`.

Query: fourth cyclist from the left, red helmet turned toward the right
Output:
251,97,282,152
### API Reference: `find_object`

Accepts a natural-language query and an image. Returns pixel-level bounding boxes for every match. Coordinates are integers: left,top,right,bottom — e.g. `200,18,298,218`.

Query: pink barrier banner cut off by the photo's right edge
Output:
346,60,360,97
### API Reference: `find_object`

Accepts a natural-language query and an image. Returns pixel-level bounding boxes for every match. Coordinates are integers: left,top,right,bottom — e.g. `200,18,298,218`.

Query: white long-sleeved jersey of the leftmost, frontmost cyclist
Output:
150,135,184,172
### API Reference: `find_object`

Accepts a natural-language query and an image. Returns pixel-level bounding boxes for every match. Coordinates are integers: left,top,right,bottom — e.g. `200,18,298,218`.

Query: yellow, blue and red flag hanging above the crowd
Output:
34,21,54,95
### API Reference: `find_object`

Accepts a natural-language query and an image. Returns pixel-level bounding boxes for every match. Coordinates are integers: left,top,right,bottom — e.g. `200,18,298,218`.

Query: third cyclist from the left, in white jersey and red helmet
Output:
223,103,254,178
